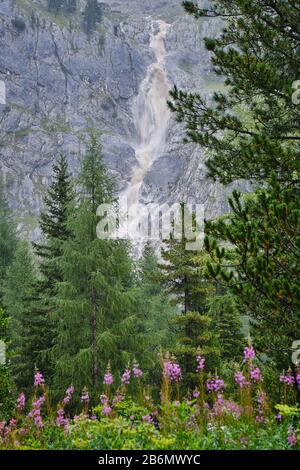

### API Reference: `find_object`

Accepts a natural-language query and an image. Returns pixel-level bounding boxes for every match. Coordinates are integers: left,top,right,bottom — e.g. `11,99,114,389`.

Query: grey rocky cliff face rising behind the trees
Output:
0,0,230,238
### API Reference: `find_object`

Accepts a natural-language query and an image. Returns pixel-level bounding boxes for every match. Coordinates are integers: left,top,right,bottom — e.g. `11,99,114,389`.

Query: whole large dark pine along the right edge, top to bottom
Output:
170,0,300,367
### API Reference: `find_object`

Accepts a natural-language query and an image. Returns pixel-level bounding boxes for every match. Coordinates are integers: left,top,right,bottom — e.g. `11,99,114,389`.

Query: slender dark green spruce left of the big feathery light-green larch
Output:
15,155,73,388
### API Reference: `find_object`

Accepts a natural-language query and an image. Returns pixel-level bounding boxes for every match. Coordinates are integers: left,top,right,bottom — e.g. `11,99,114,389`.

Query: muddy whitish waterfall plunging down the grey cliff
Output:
122,20,170,239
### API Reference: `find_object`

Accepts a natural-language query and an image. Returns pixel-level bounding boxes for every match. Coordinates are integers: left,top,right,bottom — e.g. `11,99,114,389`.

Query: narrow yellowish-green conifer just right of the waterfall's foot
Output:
161,208,219,386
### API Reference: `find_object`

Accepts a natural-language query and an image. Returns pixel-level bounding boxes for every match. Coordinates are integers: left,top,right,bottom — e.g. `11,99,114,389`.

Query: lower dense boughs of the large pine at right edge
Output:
206,180,300,367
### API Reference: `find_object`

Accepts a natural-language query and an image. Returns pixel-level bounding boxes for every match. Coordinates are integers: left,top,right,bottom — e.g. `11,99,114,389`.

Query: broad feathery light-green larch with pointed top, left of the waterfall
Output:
54,135,135,393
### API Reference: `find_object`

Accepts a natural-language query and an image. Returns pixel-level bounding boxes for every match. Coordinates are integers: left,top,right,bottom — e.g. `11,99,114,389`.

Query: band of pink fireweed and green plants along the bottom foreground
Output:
0,345,300,450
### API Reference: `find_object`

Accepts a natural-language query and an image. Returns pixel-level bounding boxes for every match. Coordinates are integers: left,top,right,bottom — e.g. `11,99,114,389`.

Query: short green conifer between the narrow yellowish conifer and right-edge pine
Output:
208,292,245,361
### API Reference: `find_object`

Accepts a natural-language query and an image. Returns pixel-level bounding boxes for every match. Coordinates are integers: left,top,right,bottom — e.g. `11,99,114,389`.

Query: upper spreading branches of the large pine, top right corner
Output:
170,0,300,183
